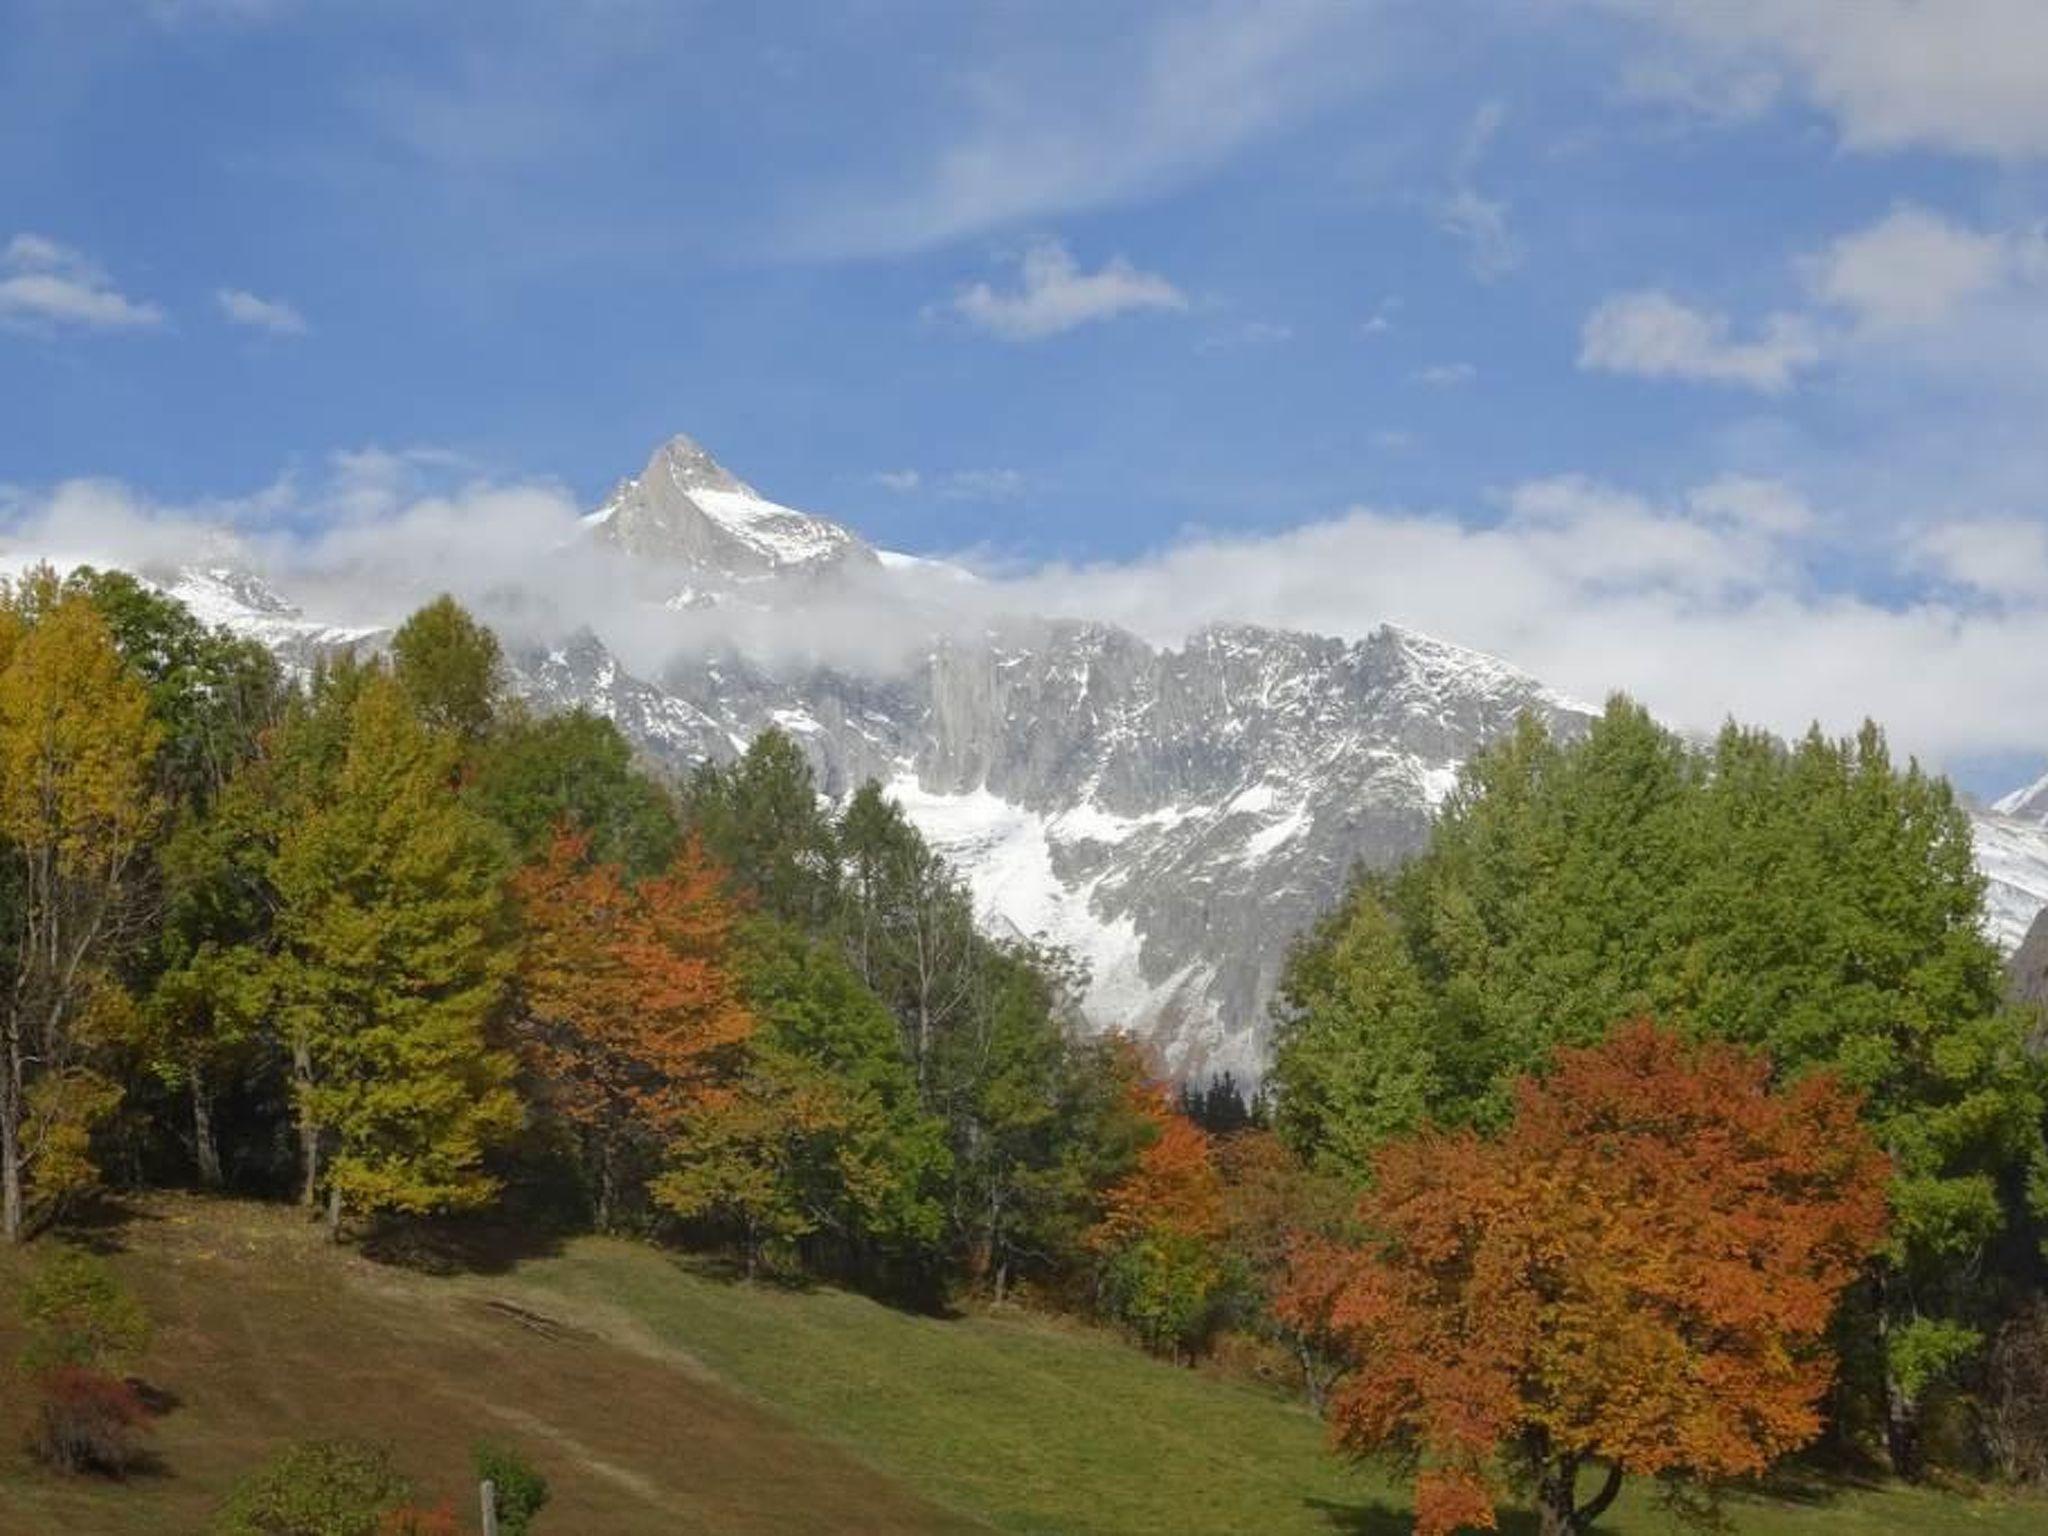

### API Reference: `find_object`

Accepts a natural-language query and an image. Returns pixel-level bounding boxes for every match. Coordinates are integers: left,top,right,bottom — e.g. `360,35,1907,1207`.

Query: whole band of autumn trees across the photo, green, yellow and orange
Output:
0,569,2048,1536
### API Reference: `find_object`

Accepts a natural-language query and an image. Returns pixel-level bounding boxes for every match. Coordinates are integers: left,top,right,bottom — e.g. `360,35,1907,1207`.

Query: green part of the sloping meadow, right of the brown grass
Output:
499,1241,2048,1536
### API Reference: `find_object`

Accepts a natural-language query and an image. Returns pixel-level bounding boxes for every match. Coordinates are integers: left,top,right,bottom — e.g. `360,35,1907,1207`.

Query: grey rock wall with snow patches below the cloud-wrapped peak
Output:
499,589,1583,1077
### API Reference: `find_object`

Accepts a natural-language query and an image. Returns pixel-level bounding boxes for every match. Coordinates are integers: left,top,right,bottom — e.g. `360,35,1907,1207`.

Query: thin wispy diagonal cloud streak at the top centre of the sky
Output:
791,0,1380,256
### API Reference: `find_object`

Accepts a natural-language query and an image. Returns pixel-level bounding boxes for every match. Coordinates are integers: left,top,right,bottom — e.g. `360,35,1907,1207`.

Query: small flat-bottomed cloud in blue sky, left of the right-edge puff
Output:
1579,289,1823,395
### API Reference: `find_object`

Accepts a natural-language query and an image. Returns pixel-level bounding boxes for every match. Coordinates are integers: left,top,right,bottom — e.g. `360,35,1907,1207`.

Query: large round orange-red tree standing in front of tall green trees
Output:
1282,1022,1888,1536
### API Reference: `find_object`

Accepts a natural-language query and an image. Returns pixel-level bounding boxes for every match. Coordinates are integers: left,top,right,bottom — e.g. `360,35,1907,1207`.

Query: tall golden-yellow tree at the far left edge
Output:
0,567,162,1243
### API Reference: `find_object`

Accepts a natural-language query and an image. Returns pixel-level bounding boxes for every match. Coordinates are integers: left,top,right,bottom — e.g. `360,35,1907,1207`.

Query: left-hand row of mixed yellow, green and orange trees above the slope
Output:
0,571,1196,1298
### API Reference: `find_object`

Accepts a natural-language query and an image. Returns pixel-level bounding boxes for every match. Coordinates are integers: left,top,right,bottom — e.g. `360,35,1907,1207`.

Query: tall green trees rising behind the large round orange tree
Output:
1276,700,2048,1473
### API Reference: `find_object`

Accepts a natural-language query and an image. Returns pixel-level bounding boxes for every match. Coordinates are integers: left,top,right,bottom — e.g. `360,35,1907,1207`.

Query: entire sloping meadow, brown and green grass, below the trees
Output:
0,1198,2048,1536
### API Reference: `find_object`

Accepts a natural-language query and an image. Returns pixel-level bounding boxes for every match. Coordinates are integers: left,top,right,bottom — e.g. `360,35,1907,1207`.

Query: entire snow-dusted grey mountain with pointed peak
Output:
16,438,2048,1077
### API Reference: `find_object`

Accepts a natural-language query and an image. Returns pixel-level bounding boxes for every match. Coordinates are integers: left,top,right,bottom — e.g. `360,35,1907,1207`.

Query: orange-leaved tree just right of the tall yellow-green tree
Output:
514,829,754,1227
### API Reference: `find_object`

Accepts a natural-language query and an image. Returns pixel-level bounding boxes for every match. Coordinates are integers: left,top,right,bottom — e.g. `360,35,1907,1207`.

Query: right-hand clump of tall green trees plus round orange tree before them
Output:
1268,698,2048,1530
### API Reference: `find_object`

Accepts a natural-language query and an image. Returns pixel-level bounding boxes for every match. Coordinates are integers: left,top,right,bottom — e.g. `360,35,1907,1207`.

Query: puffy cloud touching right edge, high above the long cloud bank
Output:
1804,205,2048,330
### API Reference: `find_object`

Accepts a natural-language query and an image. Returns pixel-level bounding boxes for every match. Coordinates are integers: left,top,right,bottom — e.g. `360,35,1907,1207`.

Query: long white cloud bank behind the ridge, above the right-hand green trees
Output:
974,477,2048,764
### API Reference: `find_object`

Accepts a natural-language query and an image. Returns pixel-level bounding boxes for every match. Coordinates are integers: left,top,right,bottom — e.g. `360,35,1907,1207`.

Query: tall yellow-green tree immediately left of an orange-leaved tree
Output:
272,676,522,1233
